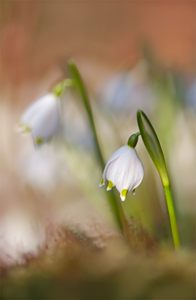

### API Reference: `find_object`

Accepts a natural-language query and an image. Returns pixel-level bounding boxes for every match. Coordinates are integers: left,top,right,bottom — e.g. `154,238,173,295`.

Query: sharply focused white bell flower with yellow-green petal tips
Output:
100,145,144,201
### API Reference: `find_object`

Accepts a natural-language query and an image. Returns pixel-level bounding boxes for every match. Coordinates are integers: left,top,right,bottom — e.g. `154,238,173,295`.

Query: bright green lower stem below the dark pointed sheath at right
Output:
163,185,180,249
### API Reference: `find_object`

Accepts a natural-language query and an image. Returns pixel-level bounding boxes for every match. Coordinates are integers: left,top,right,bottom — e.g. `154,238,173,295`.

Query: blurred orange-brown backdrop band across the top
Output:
0,0,196,96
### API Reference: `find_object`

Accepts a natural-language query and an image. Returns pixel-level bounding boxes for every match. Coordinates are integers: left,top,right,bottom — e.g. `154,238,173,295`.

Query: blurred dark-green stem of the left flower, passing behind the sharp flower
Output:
68,61,127,235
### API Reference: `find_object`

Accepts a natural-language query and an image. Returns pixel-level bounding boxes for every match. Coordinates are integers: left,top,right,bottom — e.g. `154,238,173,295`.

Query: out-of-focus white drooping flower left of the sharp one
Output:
20,93,61,144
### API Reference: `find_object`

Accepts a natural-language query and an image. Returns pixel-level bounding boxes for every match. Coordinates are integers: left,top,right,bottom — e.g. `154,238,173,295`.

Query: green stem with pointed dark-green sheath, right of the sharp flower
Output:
137,110,180,249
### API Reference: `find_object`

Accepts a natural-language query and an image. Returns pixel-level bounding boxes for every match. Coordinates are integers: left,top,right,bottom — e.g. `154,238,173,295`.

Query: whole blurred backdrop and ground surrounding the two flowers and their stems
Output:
0,0,196,300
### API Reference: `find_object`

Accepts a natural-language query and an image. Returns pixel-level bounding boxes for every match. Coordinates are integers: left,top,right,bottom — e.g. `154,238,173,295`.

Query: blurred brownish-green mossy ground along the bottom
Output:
0,242,196,300
